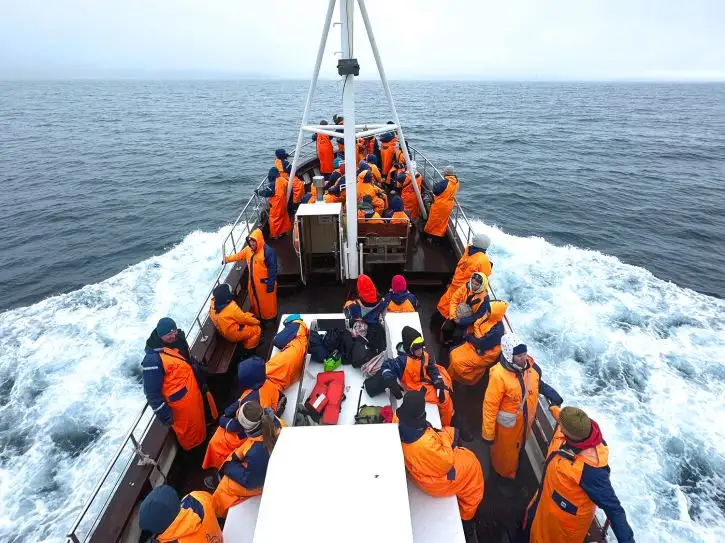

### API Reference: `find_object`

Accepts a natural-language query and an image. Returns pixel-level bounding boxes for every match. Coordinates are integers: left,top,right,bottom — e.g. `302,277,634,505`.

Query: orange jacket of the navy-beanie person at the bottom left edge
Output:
155,490,223,543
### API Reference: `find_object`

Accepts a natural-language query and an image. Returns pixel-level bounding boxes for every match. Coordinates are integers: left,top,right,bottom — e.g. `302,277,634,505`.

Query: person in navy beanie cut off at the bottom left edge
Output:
138,485,224,543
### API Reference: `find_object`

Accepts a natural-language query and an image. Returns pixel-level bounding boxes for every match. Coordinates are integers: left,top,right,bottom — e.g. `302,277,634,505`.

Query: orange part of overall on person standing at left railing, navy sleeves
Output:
159,347,206,451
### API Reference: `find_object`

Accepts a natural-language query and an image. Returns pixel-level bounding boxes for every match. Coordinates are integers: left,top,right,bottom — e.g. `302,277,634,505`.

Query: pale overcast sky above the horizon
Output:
0,0,725,80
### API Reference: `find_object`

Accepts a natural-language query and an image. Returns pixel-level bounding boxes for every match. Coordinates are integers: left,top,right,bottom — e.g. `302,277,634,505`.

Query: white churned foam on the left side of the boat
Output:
0,227,228,541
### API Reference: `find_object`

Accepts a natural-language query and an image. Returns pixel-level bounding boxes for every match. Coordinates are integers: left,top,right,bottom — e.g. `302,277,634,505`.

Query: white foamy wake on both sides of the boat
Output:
0,223,725,542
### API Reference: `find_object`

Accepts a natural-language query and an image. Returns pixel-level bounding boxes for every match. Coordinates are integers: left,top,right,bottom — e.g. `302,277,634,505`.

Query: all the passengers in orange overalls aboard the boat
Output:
139,130,634,543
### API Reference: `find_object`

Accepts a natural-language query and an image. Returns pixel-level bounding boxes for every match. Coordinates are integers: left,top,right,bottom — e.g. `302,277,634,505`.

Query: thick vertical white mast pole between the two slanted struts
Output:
340,0,360,279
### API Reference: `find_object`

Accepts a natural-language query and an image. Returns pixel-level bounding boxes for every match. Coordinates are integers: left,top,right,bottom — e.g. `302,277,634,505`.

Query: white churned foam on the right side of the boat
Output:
475,222,725,543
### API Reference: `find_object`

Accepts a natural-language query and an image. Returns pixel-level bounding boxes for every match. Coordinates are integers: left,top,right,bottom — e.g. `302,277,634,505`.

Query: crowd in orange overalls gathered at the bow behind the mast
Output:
256,116,459,241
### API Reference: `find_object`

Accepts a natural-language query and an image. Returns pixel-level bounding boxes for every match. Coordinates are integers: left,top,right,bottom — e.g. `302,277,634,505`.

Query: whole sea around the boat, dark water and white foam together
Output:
0,80,725,543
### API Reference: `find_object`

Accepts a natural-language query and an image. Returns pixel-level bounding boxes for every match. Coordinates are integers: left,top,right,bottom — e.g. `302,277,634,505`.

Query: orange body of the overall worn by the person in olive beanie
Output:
525,414,609,543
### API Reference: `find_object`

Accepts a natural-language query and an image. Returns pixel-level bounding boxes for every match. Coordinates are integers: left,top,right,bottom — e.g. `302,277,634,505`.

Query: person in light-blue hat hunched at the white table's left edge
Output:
267,313,310,391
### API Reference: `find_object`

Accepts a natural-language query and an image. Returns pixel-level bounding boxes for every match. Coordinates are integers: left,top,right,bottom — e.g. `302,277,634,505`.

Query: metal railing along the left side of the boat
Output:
66,141,316,543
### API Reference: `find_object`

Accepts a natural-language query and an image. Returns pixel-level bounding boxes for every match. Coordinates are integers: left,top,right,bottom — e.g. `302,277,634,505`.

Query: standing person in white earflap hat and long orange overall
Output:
482,334,563,479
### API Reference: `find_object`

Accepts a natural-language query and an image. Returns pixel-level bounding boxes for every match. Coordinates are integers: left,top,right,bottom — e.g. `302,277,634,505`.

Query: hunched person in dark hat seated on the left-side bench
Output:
209,283,262,350
